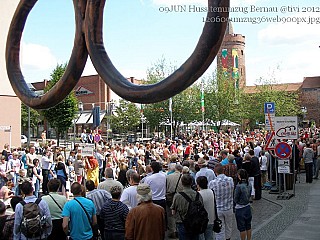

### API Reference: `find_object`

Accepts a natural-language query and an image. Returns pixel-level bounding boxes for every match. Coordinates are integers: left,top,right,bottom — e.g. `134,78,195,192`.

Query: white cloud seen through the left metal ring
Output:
21,42,58,70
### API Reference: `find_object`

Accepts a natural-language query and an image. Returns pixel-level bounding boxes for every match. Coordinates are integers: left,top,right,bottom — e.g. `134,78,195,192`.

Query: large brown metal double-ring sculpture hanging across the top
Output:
6,0,229,109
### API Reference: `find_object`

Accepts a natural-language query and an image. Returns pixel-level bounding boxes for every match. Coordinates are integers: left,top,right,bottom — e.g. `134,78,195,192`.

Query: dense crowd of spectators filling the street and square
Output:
0,126,320,240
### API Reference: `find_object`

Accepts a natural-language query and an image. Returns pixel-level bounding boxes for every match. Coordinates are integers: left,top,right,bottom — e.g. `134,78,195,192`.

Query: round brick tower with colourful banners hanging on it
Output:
217,22,246,88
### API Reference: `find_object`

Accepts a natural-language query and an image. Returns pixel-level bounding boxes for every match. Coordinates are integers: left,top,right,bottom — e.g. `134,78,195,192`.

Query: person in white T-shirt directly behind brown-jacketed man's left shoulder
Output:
120,173,140,210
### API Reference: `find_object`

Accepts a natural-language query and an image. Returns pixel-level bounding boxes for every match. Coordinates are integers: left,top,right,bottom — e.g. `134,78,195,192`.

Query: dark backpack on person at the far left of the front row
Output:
20,198,44,238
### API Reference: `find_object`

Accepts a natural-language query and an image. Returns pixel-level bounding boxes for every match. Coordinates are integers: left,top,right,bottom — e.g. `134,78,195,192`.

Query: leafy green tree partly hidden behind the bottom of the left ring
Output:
42,64,78,145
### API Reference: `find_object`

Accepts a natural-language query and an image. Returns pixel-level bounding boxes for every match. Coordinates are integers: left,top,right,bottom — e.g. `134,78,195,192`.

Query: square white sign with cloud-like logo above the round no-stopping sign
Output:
275,116,298,139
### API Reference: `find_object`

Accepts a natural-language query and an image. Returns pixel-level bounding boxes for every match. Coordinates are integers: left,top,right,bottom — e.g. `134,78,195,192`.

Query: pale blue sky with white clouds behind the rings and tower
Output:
21,0,320,85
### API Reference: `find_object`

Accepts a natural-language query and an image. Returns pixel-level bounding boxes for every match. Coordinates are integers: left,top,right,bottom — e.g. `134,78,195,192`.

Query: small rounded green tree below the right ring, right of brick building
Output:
110,100,141,132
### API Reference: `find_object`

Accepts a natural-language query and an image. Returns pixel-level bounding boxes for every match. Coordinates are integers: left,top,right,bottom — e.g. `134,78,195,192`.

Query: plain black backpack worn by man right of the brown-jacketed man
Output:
179,192,209,234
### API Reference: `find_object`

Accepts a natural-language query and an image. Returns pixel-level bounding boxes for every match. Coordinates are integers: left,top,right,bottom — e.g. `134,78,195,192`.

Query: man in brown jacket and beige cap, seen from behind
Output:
125,183,166,240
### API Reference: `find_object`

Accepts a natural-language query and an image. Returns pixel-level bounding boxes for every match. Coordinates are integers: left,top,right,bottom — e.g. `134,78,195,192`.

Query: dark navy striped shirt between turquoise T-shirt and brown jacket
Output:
100,199,129,232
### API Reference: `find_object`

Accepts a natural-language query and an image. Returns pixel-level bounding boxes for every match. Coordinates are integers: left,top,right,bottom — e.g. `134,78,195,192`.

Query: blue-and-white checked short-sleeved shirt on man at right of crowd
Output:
208,174,234,211
